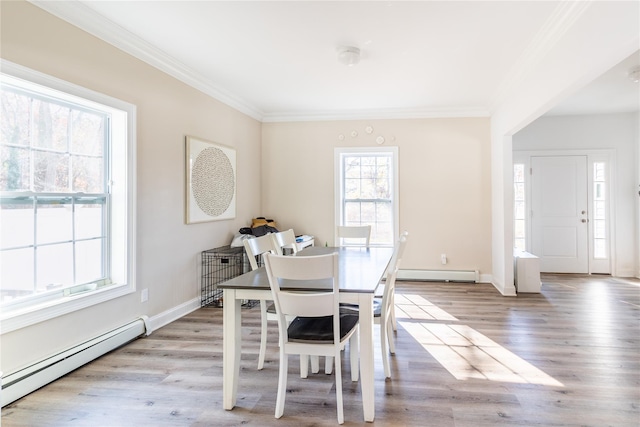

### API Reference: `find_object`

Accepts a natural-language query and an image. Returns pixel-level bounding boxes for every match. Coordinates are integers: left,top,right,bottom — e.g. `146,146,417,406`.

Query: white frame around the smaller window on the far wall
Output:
333,147,400,247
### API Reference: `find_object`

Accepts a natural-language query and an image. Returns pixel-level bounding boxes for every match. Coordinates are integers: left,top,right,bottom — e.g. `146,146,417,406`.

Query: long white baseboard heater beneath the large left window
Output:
0,316,148,407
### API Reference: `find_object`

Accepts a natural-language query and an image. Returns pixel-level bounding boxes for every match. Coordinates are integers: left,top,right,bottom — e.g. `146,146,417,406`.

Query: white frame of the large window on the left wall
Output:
0,60,136,334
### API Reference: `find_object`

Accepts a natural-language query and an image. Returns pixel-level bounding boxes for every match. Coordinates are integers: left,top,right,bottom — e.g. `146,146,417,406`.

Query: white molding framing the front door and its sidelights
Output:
511,149,617,277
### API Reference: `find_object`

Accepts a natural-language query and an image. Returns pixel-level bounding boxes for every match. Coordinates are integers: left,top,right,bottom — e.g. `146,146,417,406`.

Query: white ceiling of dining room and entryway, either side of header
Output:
33,0,640,121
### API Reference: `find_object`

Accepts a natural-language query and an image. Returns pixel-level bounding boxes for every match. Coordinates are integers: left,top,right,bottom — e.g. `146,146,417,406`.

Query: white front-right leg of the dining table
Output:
359,293,376,422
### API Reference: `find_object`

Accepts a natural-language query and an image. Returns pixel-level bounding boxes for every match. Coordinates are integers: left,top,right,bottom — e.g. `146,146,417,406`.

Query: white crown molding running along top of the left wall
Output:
28,0,264,121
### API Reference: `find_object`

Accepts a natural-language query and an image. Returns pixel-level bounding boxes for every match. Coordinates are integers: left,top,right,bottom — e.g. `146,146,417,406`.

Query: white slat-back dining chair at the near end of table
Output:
264,253,359,424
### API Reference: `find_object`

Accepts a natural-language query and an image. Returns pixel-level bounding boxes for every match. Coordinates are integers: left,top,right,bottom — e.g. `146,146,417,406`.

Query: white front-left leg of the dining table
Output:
222,289,242,410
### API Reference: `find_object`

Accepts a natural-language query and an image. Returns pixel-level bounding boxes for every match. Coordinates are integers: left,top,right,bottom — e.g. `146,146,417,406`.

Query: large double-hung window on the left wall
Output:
0,62,135,332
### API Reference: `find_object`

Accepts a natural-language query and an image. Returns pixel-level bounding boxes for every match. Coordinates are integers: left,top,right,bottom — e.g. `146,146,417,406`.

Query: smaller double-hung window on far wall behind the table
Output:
335,147,398,246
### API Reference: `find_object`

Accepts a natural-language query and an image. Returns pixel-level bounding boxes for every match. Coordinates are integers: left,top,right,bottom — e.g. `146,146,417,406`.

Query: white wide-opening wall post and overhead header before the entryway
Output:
491,1,640,295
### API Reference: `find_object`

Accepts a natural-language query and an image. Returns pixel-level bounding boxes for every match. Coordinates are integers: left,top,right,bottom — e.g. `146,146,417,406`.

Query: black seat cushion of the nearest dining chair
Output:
287,313,358,343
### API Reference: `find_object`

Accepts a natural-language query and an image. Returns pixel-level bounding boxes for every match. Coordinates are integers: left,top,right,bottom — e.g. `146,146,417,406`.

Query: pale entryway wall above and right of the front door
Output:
513,113,639,277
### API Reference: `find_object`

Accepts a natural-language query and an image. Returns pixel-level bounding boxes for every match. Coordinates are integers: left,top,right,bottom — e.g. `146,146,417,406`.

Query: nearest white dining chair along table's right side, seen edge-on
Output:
340,231,409,378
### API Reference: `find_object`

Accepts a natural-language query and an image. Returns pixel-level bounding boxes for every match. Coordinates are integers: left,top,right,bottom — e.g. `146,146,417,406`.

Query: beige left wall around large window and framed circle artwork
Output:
0,2,260,374
